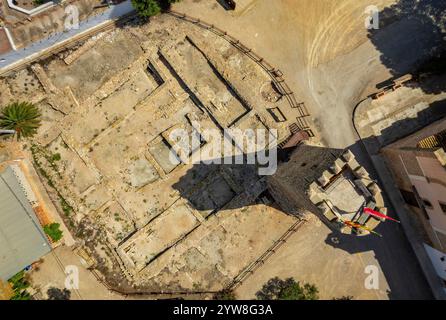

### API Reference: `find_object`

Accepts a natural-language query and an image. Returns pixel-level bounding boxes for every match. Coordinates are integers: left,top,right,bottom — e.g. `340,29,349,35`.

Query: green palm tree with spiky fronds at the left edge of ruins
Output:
0,102,41,139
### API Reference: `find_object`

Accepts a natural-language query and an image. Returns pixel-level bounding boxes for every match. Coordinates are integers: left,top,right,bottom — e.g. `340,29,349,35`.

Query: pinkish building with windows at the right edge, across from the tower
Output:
381,119,446,281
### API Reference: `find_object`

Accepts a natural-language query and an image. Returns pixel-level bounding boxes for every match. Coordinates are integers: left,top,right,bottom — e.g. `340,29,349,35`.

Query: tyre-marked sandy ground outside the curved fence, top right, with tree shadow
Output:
174,0,440,148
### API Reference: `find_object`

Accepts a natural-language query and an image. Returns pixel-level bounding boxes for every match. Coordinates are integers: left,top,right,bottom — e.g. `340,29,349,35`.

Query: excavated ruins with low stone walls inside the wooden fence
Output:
2,15,304,295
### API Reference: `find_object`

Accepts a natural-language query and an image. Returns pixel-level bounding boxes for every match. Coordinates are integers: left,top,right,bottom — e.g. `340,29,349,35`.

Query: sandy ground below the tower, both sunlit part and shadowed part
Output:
236,218,431,300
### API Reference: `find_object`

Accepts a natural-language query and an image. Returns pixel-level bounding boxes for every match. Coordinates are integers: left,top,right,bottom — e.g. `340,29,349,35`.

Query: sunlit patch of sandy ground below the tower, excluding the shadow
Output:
236,215,389,300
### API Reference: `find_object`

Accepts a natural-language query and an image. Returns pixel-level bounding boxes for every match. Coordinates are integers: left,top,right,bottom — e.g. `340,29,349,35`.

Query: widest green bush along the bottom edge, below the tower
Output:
256,277,319,300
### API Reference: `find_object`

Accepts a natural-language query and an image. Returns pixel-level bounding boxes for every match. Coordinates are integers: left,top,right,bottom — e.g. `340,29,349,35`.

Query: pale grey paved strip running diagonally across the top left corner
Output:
0,0,133,71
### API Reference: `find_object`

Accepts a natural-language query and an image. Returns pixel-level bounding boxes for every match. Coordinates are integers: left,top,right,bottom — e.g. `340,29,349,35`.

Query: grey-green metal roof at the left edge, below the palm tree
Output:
0,167,51,281
